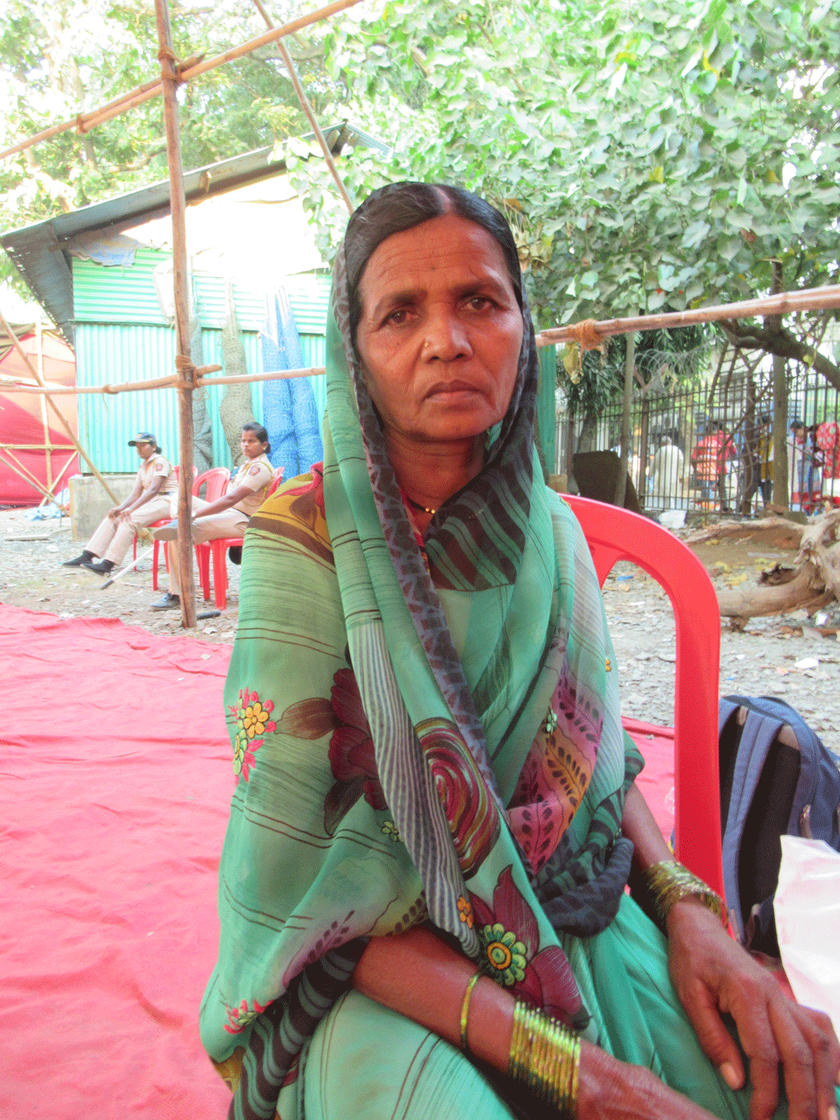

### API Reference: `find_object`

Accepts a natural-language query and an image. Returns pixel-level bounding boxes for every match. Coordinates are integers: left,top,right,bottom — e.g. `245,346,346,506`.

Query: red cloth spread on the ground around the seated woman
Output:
0,605,673,1120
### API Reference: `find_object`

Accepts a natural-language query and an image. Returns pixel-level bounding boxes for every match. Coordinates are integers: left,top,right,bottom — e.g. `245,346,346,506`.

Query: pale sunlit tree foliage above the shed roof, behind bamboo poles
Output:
0,0,335,288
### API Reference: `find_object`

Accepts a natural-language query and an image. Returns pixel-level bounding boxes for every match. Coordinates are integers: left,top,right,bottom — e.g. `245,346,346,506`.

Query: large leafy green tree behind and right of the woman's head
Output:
288,0,840,388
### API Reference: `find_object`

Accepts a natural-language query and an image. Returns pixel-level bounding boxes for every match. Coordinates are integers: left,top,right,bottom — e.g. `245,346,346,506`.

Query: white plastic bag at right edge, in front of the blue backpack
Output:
773,836,840,1036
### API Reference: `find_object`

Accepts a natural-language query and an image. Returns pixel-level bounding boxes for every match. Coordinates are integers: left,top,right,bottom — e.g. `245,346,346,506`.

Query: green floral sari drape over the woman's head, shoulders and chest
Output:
202,188,641,1118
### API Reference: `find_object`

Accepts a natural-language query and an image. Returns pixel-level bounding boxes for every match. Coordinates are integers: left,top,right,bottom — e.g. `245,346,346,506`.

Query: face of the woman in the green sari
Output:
356,214,523,442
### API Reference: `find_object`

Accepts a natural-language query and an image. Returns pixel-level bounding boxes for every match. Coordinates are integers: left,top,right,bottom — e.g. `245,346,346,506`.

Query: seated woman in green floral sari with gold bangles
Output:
202,184,840,1120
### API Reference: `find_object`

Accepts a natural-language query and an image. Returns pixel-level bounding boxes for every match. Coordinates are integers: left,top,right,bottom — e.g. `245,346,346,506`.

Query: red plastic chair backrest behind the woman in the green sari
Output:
563,494,724,895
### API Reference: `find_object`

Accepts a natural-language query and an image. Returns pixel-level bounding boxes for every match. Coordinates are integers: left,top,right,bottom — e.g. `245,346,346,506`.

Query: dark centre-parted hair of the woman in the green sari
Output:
344,183,522,342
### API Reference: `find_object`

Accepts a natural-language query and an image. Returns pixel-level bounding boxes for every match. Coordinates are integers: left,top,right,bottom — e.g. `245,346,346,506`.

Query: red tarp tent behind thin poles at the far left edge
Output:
0,330,78,505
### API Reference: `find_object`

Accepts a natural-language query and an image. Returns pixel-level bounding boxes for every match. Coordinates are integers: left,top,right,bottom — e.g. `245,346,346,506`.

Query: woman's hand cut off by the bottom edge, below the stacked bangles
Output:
577,1042,715,1120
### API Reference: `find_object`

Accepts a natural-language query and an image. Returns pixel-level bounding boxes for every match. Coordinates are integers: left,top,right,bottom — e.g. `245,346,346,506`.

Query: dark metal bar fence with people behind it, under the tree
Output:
556,353,840,514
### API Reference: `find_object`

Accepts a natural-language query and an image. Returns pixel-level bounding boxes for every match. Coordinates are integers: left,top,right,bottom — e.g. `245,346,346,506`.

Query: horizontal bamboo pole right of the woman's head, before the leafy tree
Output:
536,284,840,349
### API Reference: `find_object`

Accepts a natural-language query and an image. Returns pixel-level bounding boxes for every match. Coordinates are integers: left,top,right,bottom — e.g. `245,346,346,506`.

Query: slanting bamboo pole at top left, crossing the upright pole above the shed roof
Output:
0,0,361,159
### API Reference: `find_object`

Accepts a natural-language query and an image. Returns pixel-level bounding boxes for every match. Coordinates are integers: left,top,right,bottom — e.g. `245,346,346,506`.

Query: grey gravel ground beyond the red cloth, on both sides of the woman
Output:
0,510,840,753
